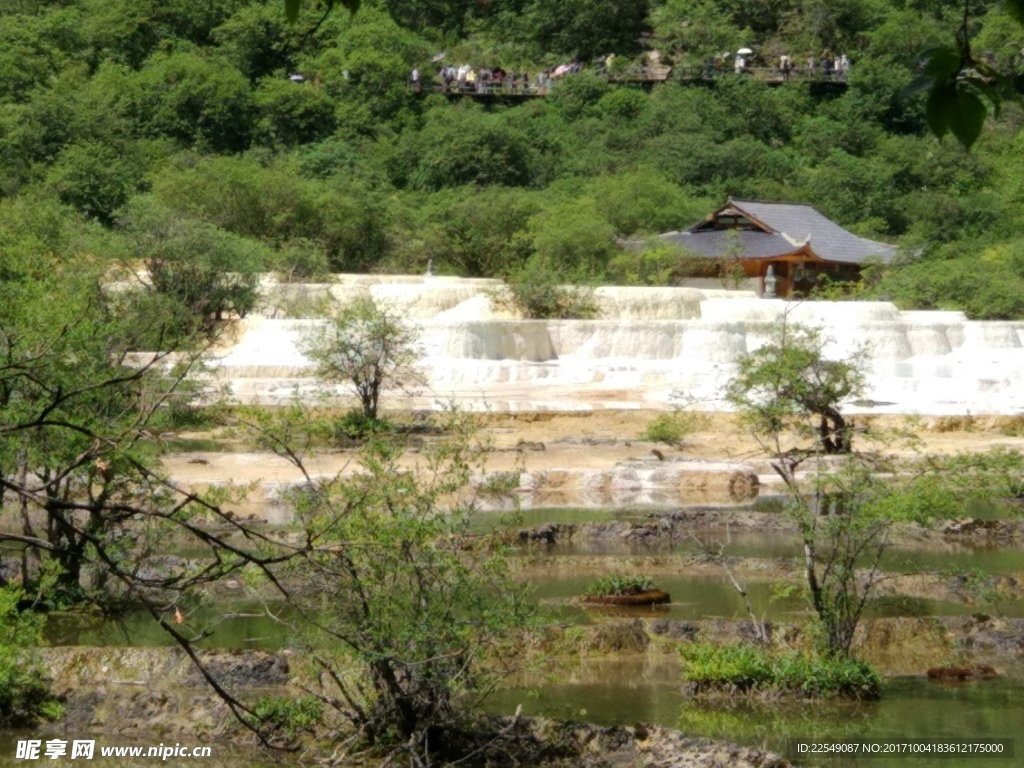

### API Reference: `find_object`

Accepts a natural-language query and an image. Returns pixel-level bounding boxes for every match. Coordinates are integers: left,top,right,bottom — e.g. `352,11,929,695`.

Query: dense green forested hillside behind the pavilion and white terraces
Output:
0,0,1024,317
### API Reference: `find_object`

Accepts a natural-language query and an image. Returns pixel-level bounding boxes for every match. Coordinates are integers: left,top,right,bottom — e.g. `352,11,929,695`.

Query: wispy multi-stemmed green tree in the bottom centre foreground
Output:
238,408,530,766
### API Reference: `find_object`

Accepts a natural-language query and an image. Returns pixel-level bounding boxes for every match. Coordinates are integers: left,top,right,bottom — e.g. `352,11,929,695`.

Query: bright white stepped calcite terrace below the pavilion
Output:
214,275,1024,415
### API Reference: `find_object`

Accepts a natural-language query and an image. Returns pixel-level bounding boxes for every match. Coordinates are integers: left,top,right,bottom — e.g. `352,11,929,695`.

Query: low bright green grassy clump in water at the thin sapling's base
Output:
679,643,882,698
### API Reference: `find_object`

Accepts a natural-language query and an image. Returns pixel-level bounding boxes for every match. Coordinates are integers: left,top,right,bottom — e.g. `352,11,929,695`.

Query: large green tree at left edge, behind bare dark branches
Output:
0,226,195,603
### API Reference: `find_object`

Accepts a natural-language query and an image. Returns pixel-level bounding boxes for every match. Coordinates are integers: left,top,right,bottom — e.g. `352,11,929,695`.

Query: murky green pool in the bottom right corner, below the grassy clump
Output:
490,670,1024,768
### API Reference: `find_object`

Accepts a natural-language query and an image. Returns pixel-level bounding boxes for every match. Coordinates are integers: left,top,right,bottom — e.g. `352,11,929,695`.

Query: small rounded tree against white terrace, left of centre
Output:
308,298,423,421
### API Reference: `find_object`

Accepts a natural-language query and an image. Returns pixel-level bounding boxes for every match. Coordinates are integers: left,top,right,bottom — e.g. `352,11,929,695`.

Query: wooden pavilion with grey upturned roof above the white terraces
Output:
660,198,896,297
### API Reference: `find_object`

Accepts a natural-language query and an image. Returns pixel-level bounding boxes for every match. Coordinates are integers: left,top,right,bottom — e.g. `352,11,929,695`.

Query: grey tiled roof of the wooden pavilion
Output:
660,198,896,264
